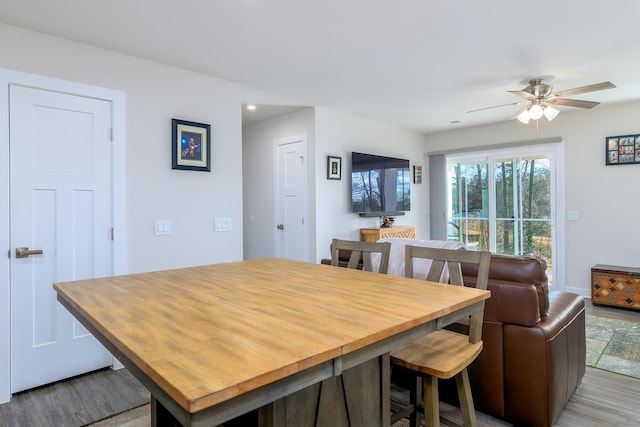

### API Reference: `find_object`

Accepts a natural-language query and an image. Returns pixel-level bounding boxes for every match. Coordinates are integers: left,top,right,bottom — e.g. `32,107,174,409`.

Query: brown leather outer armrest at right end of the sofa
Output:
504,291,586,426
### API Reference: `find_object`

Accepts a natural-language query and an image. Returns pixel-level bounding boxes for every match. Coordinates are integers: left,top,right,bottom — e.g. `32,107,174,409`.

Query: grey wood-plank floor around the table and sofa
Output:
0,301,640,427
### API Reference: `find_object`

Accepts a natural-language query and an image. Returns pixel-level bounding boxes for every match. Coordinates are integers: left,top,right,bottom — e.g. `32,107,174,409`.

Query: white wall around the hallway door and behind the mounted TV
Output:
243,108,428,262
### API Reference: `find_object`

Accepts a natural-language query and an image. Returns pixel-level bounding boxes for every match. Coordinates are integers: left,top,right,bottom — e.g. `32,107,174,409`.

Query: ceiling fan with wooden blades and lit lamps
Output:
467,79,616,124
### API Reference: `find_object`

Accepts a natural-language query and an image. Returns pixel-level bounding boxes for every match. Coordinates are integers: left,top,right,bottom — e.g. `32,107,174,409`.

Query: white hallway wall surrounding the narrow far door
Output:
242,108,315,261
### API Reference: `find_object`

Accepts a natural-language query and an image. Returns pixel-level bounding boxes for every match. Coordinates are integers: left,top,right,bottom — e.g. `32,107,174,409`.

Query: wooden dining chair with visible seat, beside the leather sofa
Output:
391,245,491,427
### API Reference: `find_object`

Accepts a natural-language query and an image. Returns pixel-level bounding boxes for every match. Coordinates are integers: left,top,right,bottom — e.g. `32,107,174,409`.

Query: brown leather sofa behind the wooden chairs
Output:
323,249,586,427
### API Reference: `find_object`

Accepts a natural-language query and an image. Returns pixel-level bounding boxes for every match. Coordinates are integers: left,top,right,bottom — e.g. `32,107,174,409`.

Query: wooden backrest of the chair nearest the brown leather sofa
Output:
405,245,491,343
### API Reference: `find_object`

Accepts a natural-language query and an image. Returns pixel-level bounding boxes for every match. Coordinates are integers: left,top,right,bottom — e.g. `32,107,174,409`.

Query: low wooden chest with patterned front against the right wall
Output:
591,264,640,310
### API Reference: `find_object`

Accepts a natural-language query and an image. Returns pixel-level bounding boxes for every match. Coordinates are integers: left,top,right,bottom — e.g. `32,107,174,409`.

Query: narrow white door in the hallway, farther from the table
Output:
276,137,309,261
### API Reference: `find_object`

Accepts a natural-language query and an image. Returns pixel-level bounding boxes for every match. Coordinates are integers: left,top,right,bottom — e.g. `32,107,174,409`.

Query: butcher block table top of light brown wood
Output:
54,258,489,413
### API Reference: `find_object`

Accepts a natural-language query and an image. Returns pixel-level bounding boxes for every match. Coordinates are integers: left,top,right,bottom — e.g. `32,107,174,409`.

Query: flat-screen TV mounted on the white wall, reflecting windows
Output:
351,152,411,216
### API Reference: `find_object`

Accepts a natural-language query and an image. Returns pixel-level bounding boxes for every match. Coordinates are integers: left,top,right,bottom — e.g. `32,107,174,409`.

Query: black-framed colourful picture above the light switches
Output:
171,119,211,172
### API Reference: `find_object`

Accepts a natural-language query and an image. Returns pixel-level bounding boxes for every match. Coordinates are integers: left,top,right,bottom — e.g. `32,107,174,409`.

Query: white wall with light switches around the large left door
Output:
0,24,242,273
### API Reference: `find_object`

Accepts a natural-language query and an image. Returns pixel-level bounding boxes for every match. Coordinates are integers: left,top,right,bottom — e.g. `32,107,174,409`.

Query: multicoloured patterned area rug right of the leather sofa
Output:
586,315,640,378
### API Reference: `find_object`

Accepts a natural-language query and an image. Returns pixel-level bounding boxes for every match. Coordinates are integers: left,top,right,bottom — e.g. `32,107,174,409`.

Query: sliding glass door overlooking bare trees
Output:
447,146,556,288
